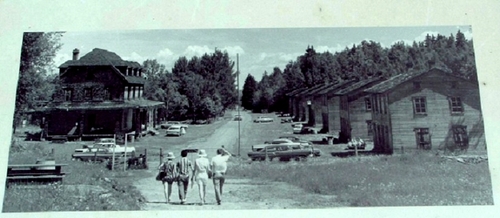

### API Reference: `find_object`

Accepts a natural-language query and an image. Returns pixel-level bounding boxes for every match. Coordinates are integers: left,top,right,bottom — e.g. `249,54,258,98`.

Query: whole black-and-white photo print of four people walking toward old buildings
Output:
0,0,497,216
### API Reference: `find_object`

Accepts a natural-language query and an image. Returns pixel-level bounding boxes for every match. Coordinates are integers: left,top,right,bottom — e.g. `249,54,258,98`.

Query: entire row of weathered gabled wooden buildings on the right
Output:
287,69,486,153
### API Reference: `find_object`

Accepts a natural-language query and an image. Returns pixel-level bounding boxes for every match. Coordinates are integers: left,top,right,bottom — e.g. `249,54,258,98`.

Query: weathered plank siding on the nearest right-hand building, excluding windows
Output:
384,74,485,149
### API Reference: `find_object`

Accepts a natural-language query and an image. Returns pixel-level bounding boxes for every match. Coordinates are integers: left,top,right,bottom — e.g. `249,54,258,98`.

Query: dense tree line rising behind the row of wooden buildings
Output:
241,31,477,112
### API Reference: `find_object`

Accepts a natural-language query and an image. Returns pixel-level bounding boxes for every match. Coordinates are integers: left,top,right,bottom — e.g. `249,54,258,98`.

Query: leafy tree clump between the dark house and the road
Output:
143,50,238,120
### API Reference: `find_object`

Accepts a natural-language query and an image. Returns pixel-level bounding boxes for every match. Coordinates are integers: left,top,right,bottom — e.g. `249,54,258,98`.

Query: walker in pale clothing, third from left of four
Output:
191,149,212,205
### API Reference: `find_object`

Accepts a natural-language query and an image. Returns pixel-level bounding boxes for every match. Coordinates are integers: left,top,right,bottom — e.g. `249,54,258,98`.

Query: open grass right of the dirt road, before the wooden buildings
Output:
230,112,493,206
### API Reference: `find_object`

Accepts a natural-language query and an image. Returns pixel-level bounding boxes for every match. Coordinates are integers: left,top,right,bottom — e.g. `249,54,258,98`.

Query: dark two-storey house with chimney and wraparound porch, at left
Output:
40,48,163,140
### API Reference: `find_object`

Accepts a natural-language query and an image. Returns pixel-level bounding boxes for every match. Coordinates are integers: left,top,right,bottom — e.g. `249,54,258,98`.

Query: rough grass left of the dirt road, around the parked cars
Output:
3,118,227,212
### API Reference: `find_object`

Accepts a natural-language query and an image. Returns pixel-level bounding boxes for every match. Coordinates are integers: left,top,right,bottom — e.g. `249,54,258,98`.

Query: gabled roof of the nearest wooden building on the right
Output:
365,68,470,93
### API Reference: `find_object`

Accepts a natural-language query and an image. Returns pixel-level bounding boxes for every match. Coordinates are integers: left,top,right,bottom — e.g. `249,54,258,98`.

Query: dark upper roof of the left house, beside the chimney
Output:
59,48,142,68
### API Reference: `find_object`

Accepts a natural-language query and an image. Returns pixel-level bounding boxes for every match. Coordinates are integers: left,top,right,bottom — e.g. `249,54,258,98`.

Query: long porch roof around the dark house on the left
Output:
37,99,164,111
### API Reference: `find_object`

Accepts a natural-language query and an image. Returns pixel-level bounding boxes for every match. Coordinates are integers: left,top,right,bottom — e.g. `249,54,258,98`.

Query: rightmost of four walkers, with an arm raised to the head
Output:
210,145,231,205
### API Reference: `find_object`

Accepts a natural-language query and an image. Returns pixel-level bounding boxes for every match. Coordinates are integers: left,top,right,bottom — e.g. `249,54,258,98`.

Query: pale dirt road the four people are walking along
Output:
134,112,339,210
